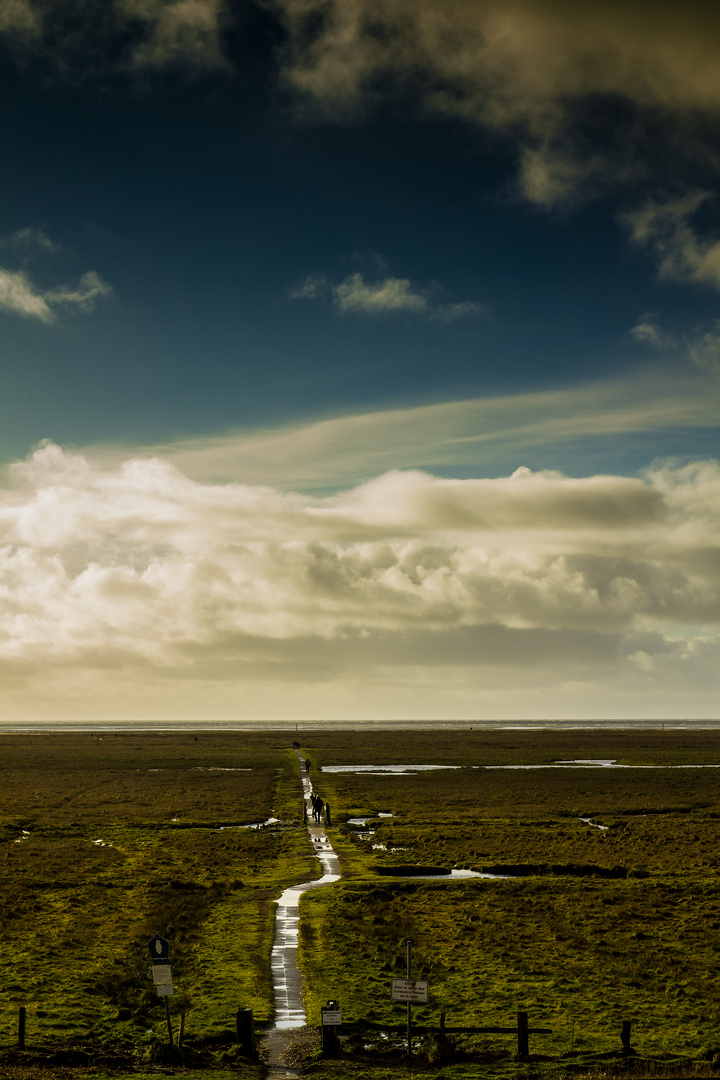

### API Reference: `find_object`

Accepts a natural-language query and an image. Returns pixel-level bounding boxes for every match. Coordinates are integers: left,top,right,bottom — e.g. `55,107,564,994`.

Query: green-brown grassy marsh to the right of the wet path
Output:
301,732,720,1056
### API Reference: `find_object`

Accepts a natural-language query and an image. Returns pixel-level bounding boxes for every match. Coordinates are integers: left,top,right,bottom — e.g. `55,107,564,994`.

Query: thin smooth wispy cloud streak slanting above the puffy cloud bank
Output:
117,369,720,490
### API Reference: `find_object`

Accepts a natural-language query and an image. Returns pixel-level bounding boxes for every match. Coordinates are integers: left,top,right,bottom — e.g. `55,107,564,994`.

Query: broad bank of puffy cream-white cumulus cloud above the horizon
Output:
0,444,720,715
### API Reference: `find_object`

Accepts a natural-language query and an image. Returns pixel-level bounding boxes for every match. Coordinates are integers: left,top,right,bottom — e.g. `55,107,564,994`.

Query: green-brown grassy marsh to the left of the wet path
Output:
0,734,318,1071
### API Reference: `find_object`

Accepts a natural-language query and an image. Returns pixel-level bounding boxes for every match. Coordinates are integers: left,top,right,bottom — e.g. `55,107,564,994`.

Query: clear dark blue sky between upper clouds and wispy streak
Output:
0,3,718,477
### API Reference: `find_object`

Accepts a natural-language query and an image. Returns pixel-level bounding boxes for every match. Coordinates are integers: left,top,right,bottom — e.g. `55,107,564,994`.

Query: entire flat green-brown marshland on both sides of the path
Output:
0,730,720,1078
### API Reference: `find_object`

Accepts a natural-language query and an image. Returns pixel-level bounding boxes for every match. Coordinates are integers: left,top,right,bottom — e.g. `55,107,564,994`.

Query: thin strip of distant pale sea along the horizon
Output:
0,719,720,734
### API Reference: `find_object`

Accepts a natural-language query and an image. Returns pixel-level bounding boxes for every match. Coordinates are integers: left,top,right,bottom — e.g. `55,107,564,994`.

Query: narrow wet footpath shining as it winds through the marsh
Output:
262,751,340,1080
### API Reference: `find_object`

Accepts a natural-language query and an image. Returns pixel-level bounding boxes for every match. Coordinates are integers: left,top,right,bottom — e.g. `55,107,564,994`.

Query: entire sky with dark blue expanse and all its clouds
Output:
0,0,720,718
